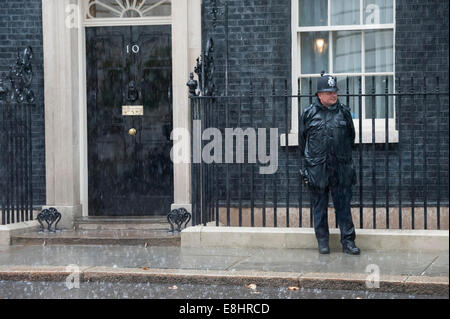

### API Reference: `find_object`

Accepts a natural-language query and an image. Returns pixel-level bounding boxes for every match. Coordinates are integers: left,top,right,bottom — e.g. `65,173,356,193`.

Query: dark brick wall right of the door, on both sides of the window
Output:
203,0,448,209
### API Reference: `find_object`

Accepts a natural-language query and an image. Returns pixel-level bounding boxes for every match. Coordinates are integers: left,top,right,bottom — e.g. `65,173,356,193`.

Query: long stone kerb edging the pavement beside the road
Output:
0,266,449,297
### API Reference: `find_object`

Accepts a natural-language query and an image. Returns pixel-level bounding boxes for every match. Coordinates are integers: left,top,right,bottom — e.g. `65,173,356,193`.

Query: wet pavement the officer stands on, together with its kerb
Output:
0,245,449,296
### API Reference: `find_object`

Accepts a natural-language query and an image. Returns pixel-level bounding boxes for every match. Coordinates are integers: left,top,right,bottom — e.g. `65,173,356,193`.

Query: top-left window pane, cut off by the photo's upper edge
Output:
298,0,328,27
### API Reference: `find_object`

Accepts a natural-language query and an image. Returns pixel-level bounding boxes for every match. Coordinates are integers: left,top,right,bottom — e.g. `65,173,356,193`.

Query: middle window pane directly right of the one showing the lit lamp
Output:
333,31,361,73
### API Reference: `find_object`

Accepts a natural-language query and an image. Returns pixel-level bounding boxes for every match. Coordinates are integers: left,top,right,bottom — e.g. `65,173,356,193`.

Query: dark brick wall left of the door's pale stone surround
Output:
0,0,45,205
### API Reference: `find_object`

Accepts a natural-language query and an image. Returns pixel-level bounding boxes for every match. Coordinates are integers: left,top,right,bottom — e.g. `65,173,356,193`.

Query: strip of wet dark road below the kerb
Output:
0,281,447,299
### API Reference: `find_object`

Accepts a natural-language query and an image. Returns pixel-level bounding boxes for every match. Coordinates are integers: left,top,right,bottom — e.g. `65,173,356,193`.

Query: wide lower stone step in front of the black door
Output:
11,230,181,246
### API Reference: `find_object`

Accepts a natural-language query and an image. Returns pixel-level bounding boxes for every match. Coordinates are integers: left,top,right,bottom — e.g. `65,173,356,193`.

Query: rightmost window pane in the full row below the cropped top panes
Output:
364,30,394,72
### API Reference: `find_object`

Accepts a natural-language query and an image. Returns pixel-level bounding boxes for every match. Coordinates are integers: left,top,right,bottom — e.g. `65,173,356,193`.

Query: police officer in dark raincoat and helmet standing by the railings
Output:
299,71,360,255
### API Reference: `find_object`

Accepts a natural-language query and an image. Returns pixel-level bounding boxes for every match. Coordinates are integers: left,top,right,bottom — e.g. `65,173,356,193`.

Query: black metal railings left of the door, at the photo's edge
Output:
0,47,35,225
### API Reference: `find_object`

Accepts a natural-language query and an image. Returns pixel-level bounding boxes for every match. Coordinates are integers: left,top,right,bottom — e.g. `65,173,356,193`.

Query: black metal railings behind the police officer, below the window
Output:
190,77,449,229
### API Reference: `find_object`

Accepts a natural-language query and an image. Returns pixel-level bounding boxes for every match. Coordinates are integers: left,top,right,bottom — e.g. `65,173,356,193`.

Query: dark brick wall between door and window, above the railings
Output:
203,0,291,94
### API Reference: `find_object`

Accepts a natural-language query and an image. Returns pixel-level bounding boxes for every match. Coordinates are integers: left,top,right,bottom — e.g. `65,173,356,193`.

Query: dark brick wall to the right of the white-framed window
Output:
395,0,449,203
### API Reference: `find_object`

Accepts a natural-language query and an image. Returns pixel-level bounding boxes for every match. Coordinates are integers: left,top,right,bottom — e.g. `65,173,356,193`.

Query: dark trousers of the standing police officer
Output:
311,185,355,248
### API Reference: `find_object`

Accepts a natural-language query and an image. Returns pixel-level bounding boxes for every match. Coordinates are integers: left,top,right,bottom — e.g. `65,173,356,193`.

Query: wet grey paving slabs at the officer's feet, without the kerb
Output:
0,245,449,277
